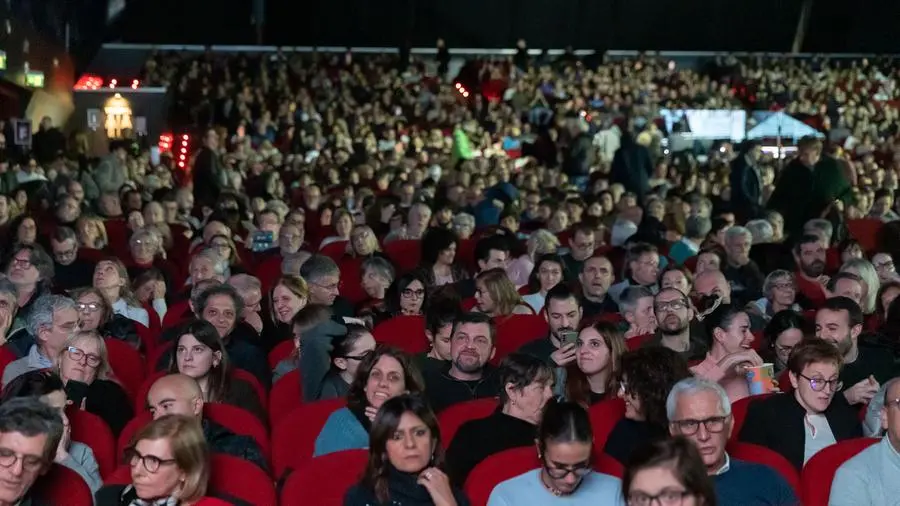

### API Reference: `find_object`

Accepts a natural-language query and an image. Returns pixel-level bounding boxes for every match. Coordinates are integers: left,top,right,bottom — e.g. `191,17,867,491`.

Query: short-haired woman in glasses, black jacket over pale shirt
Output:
739,339,862,471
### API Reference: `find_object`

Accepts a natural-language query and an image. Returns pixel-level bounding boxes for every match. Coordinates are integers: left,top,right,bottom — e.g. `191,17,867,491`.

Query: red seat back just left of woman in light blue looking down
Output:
464,446,541,506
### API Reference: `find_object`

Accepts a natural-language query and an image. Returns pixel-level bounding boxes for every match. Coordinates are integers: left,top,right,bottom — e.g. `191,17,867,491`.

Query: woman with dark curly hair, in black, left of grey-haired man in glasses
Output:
603,346,691,465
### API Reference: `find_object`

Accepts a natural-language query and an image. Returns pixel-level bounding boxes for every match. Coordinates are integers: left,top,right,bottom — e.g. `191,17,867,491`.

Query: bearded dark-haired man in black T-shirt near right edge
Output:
816,297,897,405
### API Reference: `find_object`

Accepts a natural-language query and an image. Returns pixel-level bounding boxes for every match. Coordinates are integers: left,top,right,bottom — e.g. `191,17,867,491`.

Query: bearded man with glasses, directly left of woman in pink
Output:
643,288,707,362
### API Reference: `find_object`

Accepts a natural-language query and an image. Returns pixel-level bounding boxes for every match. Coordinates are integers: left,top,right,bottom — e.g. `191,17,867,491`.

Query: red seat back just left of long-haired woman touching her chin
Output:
281,450,369,506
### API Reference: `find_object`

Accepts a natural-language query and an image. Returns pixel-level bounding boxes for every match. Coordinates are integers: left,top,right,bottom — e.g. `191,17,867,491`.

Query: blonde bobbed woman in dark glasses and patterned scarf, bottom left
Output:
94,415,230,506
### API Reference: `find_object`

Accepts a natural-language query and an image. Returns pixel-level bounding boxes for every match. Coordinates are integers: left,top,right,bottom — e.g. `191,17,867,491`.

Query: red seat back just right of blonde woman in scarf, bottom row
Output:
209,453,278,505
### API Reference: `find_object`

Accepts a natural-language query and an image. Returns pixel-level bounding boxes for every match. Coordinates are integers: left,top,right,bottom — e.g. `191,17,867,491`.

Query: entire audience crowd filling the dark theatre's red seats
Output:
0,47,900,506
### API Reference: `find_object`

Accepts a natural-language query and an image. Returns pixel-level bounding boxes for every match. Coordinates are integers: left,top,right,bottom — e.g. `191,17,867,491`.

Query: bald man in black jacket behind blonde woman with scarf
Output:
147,374,269,472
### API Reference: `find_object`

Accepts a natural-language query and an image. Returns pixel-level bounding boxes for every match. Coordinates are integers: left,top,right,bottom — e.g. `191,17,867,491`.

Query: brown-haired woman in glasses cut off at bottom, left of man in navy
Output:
622,437,712,506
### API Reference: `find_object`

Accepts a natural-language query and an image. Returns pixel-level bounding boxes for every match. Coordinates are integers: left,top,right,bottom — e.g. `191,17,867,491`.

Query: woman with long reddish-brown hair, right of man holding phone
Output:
559,321,625,408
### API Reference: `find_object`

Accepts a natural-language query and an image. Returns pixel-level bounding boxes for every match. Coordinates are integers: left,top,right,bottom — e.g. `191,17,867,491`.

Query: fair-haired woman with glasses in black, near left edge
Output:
59,330,134,436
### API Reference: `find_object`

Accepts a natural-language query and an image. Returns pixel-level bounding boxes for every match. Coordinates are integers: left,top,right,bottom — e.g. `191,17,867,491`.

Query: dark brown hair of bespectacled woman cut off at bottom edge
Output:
622,436,717,506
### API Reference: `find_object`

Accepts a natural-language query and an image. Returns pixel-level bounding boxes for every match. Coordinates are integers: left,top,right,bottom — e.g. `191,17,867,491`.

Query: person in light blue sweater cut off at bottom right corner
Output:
828,379,900,506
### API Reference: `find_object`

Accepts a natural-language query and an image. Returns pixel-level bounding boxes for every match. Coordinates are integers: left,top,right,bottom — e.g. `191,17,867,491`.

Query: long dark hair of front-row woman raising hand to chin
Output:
362,394,444,504
